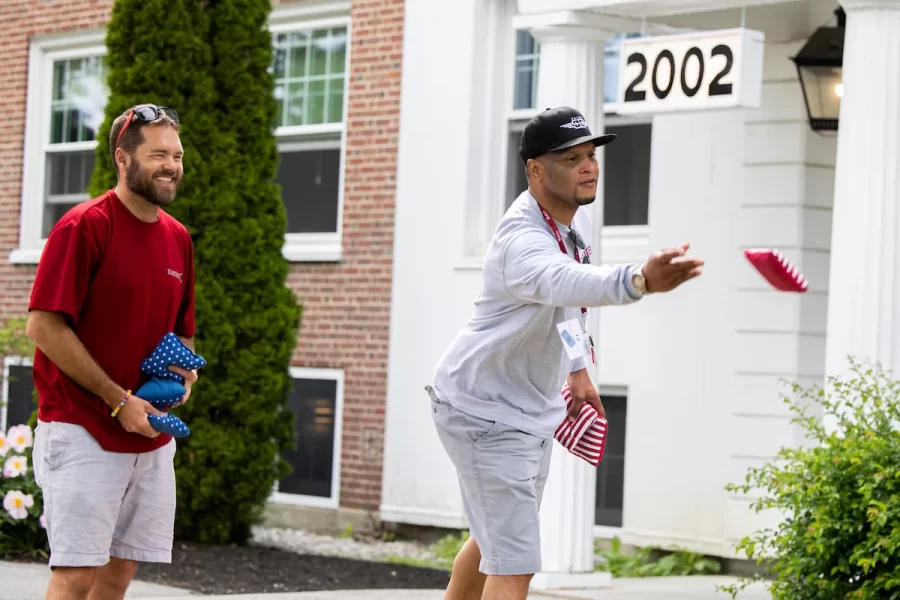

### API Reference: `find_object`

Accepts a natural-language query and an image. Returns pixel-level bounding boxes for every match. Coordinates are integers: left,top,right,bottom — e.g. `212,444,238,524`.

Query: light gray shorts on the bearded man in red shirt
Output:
32,421,175,567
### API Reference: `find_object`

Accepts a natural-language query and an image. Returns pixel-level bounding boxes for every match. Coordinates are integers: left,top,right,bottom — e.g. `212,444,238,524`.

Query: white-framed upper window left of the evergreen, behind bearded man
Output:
10,33,109,262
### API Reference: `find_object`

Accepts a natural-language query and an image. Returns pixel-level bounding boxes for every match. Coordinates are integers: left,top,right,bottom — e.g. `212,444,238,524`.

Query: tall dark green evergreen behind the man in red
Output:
92,0,300,543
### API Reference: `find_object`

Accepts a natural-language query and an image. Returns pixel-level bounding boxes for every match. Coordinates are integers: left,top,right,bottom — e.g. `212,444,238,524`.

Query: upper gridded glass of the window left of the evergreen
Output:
50,56,109,144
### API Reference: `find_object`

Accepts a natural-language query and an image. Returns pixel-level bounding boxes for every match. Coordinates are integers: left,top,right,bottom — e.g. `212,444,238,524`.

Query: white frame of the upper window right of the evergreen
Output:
269,2,353,262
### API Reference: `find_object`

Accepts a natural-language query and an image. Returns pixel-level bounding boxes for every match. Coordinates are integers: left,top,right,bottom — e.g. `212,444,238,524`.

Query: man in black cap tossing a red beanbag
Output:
427,107,703,600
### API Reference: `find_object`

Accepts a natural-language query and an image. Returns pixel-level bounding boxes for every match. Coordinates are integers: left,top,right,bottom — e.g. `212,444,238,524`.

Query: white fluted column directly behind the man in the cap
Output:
517,11,613,589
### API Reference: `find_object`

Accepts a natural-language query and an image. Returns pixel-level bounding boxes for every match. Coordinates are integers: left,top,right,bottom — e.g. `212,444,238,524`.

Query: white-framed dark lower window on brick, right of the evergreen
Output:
272,368,344,508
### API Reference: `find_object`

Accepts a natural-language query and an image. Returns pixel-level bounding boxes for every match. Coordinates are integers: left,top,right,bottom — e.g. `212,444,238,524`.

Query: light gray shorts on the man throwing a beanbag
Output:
428,386,553,575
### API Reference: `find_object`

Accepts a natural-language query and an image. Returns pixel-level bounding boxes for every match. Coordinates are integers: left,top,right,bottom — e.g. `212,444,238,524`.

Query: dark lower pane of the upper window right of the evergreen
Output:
278,148,341,233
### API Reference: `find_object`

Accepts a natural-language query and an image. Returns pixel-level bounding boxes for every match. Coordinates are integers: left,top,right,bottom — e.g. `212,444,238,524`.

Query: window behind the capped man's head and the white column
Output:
504,31,652,232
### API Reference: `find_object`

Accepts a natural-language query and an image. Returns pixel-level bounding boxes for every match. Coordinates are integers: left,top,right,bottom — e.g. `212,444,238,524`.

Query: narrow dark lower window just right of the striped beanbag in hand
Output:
594,394,628,527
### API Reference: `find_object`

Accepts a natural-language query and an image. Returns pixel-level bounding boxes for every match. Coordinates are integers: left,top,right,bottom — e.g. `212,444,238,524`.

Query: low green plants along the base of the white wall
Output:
594,538,721,577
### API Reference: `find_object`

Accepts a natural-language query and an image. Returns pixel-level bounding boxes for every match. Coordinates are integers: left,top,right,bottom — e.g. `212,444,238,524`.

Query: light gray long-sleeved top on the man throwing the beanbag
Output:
434,191,640,438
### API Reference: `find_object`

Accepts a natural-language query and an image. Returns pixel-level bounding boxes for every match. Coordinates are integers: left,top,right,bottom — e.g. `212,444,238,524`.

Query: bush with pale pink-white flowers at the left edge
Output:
0,425,50,556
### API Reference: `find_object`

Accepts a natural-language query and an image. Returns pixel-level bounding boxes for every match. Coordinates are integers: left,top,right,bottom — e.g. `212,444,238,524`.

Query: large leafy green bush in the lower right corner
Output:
724,361,900,600
